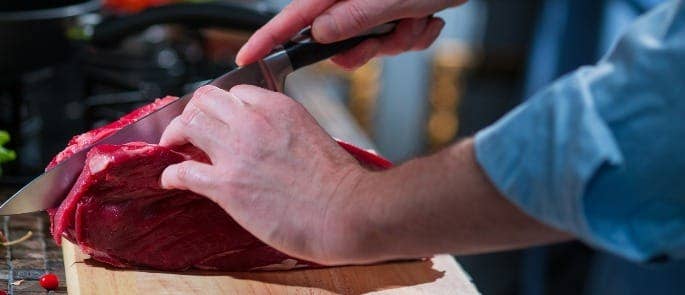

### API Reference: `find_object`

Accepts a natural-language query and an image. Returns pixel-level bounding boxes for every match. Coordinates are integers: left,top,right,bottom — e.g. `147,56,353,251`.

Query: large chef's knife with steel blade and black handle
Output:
0,23,395,215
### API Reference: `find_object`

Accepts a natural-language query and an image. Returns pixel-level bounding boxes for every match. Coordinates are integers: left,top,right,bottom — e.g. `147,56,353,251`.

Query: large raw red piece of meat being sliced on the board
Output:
48,97,391,271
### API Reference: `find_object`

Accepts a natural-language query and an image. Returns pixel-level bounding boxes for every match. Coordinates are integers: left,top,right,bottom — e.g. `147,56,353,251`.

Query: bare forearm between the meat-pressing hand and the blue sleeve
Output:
336,139,572,262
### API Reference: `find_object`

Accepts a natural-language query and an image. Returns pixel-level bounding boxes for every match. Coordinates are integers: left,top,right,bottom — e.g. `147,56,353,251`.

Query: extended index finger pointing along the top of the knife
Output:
236,0,337,66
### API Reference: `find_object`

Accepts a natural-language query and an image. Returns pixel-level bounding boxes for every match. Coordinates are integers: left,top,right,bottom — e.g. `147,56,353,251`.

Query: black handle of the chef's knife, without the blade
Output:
284,22,396,70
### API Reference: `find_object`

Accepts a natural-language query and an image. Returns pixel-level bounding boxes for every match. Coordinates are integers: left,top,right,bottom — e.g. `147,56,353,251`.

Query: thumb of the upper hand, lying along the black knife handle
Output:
312,0,464,43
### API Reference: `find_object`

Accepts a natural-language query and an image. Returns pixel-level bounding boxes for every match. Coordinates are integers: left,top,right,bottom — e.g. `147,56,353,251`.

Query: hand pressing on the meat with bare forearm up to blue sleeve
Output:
160,85,569,265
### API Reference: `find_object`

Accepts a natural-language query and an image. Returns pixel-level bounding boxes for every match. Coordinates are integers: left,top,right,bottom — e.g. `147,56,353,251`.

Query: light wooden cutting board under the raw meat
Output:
62,239,478,294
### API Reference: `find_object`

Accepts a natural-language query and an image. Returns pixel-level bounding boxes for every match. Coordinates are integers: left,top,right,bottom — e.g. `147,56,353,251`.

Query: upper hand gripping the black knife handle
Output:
236,0,466,69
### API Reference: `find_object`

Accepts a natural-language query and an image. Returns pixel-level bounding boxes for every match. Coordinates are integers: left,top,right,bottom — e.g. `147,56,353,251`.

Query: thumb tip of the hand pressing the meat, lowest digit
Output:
160,161,216,195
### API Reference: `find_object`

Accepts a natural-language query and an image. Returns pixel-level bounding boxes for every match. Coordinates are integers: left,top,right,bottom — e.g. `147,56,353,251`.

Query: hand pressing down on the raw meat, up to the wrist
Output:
160,85,368,264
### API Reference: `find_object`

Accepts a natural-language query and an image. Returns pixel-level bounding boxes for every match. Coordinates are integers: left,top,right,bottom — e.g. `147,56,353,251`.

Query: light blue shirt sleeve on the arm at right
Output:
475,0,685,261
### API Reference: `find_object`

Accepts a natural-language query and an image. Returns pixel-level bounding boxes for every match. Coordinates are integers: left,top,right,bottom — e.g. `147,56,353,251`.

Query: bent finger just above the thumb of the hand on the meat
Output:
159,104,230,158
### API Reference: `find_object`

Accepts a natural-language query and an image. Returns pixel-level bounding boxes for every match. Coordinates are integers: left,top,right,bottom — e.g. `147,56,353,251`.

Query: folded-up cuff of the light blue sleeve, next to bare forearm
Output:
475,68,622,242
